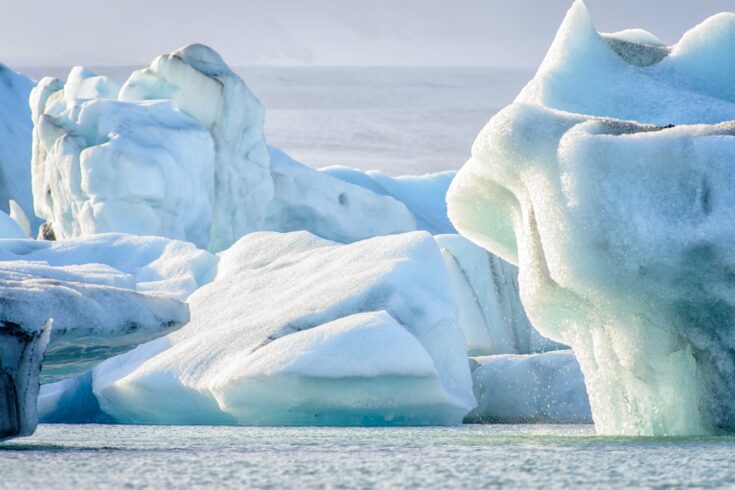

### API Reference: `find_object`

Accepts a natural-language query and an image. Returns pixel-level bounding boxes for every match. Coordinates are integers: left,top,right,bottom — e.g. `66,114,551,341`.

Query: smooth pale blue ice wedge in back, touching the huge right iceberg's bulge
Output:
320,166,455,234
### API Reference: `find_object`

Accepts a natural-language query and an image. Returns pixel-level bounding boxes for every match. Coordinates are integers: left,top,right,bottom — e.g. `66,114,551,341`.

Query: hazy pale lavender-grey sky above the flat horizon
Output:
0,0,735,66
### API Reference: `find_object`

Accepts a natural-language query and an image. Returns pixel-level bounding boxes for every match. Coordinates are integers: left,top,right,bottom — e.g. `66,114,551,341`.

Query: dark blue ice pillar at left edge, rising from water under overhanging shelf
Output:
0,318,51,441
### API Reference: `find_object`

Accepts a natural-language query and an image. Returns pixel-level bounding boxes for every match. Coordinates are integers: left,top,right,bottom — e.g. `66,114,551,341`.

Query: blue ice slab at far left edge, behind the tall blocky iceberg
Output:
0,64,40,234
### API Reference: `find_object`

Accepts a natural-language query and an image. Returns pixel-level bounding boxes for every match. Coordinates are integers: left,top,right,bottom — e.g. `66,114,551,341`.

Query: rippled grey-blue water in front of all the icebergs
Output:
0,425,735,490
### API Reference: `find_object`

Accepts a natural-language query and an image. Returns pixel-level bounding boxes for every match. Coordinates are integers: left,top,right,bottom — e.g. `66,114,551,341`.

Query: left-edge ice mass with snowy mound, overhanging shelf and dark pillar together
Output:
0,235,201,439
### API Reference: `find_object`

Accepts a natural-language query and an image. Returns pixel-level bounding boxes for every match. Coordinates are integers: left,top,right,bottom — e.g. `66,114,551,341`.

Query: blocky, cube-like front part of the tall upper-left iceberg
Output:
32,69,214,246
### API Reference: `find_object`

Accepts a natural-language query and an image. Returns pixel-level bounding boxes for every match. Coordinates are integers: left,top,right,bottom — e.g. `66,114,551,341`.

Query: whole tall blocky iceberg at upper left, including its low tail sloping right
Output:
30,44,420,252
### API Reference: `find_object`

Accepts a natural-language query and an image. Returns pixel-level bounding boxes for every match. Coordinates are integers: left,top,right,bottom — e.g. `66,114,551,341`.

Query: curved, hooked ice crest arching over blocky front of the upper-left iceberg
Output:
120,44,274,251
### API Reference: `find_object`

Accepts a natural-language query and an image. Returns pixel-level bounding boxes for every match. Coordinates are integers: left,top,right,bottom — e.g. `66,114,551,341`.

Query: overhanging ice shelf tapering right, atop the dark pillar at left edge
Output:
0,261,189,383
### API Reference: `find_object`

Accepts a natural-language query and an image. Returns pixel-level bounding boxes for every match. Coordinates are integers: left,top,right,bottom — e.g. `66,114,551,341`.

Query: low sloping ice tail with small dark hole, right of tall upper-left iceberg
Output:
263,147,416,243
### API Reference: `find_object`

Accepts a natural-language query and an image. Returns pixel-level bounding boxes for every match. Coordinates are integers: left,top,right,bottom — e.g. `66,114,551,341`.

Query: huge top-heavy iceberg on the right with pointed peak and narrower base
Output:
448,1,735,435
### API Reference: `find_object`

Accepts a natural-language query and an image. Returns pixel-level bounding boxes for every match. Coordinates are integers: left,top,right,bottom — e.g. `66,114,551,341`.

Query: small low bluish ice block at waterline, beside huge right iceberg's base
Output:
465,350,592,424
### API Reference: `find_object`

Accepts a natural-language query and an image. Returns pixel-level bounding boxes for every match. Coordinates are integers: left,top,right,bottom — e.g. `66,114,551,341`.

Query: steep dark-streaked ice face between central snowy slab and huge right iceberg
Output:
435,235,565,356
